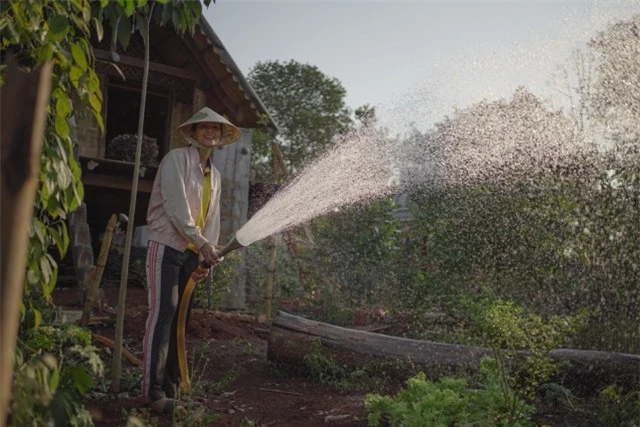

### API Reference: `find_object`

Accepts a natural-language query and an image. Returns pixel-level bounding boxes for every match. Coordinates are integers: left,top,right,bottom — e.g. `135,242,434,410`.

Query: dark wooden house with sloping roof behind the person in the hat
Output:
69,18,276,308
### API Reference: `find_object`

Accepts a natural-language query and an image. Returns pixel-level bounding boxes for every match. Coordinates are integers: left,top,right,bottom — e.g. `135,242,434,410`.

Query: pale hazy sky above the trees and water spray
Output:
204,0,640,130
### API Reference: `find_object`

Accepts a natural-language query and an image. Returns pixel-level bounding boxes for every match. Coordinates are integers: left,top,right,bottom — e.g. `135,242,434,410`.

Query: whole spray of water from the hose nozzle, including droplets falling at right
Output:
231,10,640,351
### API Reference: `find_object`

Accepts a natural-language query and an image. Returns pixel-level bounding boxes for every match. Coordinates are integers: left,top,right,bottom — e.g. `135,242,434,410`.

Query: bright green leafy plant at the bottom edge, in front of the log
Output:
365,358,534,427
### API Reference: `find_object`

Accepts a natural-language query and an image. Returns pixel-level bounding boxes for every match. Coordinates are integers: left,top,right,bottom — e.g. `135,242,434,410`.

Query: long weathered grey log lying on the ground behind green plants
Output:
267,311,640,391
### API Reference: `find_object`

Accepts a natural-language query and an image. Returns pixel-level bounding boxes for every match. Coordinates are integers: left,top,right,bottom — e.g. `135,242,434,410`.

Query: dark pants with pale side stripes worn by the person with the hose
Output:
142,241,198,402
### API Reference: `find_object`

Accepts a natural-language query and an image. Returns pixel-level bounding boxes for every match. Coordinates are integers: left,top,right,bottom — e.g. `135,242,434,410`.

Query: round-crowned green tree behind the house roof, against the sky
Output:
248,60,353,179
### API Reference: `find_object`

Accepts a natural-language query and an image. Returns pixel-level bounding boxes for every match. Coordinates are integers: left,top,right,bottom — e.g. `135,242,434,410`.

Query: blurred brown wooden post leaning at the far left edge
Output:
0,62,52,427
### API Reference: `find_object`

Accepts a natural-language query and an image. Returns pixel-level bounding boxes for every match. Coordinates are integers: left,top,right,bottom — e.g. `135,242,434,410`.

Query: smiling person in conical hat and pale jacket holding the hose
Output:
142,107,240,413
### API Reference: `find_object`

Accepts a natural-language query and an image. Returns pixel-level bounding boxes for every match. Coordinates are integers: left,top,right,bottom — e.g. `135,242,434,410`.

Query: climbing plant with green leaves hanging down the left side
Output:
0,0,211,425
